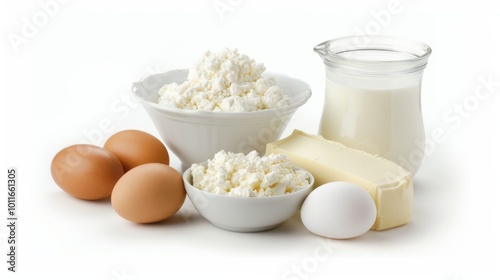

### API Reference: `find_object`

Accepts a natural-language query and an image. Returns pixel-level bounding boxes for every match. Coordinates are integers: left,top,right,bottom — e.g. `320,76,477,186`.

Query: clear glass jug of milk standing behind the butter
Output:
314,36,431,175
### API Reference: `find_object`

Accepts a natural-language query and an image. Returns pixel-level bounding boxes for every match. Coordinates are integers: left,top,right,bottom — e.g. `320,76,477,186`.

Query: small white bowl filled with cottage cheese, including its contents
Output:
183,151,314,232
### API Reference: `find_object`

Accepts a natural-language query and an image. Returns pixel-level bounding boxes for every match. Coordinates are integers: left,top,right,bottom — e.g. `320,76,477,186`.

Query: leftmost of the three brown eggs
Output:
50,144,123,200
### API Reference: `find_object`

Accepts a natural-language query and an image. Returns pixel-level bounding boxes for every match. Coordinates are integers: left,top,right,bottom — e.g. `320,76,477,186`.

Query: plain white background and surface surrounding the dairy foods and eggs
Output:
0,0,500,280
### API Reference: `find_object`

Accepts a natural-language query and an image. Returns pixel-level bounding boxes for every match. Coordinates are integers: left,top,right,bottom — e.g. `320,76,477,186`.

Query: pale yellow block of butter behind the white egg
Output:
266,130,413,230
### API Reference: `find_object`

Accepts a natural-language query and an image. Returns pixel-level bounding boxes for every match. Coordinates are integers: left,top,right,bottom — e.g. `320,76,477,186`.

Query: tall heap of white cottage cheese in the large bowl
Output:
158,49,290,112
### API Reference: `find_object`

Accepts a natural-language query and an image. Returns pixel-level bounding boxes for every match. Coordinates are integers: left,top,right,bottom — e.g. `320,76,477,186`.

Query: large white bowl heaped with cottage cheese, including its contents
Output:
132,49,311,170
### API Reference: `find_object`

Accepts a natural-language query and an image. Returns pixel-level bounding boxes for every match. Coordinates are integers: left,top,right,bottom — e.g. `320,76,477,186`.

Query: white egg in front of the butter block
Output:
300,182,377,239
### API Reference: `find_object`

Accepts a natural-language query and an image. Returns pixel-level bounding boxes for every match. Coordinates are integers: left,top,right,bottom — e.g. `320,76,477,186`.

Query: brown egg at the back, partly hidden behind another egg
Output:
104,130,170,172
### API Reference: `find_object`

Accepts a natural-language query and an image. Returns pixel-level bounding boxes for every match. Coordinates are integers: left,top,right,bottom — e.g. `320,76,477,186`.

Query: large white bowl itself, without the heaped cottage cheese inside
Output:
132,69,311,170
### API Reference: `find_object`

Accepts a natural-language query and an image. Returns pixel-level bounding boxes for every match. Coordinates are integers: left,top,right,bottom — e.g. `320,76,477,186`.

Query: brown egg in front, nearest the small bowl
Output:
111,163,186,223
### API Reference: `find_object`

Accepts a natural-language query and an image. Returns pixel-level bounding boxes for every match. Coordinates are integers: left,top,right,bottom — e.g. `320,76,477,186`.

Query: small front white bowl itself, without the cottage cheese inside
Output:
183,163,314,232
